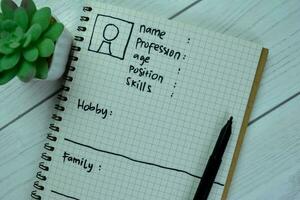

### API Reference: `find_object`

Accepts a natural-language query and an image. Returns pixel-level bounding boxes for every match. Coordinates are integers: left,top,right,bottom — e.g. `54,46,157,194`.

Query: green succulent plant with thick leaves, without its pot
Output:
0,0,64,85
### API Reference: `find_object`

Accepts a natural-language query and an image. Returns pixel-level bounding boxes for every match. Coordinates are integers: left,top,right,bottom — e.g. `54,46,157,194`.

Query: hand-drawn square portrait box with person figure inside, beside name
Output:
88,14,134,60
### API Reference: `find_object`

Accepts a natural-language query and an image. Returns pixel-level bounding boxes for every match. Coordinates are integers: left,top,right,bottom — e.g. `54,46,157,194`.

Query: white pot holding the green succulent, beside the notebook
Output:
46,29,73,80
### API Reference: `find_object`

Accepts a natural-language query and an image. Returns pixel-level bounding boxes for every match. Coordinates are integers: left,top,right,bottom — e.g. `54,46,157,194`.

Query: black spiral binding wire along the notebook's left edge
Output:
31,6,92,200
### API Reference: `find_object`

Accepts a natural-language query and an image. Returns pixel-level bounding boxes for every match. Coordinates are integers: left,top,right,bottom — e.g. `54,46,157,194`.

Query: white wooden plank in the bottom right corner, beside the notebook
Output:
229,97,300,200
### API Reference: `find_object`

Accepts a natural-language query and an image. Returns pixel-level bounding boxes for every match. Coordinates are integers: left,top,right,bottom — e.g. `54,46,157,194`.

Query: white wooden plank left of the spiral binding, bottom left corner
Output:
0,98,56,200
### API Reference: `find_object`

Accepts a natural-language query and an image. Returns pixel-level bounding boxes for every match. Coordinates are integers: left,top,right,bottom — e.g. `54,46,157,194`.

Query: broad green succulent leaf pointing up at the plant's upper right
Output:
31,7,51,31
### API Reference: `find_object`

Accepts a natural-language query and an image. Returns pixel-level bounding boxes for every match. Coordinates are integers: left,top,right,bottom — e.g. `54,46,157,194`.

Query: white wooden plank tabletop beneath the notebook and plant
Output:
0,0,300,200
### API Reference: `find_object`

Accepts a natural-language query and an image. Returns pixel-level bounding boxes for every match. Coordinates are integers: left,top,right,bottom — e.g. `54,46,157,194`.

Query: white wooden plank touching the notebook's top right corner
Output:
176,0,300,119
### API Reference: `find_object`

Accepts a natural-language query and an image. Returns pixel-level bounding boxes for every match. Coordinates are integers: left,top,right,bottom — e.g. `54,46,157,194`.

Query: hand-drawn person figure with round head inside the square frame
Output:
98,24,119,55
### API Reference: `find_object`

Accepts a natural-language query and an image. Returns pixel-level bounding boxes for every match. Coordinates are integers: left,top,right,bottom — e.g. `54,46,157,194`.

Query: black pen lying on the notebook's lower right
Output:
194,117,232,200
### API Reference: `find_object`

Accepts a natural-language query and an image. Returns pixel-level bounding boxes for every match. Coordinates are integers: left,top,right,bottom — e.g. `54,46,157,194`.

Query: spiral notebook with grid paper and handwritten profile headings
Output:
31,1,268,200
